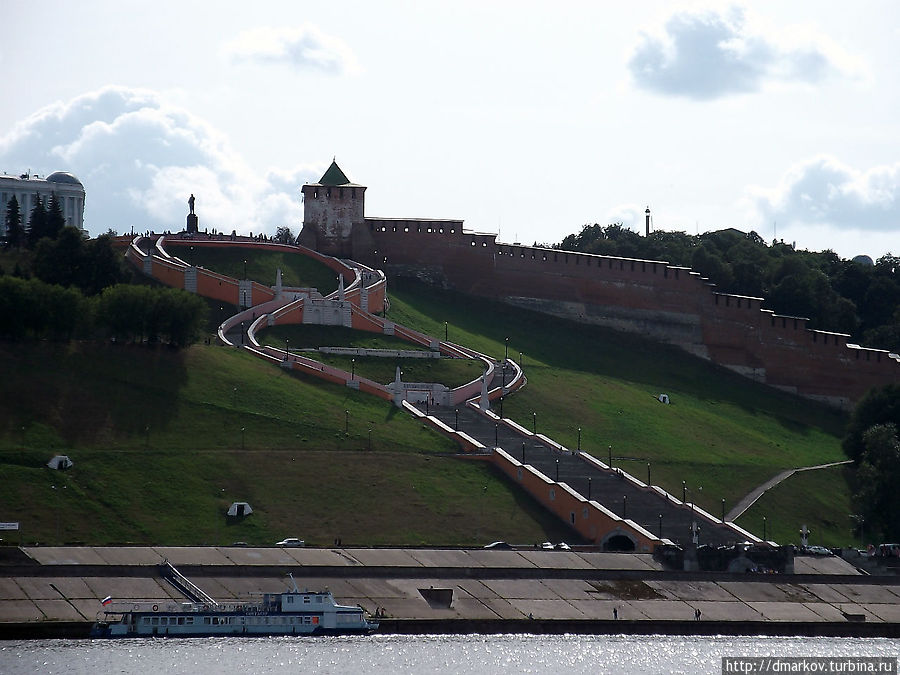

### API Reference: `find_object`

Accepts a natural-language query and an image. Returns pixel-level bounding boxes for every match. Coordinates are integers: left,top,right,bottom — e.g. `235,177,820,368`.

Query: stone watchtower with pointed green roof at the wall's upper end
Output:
298,161,366,258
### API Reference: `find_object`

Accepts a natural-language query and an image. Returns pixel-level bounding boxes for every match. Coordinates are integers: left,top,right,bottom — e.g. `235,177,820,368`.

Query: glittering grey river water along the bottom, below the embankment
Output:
0,635,900,675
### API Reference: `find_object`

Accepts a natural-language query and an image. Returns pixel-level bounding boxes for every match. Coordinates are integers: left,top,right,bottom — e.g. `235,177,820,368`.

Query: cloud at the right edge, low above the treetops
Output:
745,155,900,232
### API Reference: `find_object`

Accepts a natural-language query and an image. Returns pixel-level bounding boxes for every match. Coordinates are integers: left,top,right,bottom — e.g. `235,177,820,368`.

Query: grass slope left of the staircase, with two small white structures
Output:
0,343,568,545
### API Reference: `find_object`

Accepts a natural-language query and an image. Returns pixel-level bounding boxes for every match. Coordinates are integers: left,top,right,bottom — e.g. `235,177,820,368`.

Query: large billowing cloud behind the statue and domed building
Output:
0,87,318,234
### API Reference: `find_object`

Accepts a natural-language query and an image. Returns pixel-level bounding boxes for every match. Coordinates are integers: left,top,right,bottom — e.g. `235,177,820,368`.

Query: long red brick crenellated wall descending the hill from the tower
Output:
352,224,900,409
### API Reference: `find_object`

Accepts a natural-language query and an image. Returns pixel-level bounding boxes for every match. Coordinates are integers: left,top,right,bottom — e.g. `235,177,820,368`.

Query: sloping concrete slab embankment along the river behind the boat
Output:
0,547,900,639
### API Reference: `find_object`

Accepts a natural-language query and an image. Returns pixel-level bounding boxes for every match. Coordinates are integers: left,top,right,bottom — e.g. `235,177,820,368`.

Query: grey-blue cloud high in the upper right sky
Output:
628,7,861,100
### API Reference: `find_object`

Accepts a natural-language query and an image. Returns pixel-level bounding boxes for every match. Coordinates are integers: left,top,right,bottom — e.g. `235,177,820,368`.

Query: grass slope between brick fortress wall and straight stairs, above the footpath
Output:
389,282,846,537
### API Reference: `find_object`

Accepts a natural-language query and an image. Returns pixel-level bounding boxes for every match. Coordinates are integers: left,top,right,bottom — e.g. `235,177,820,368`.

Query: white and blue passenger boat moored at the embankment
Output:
91,572,378,638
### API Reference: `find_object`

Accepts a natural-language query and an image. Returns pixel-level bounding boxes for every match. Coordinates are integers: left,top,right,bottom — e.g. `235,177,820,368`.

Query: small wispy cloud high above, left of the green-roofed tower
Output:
224,24,358,75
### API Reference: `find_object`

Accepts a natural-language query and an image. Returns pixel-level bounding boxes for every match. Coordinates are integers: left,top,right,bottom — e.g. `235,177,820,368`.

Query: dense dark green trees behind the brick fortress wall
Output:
554,224,900,352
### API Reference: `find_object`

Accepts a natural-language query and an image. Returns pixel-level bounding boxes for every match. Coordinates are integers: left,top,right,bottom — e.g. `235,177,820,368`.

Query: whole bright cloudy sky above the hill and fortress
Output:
0,0,900,259
